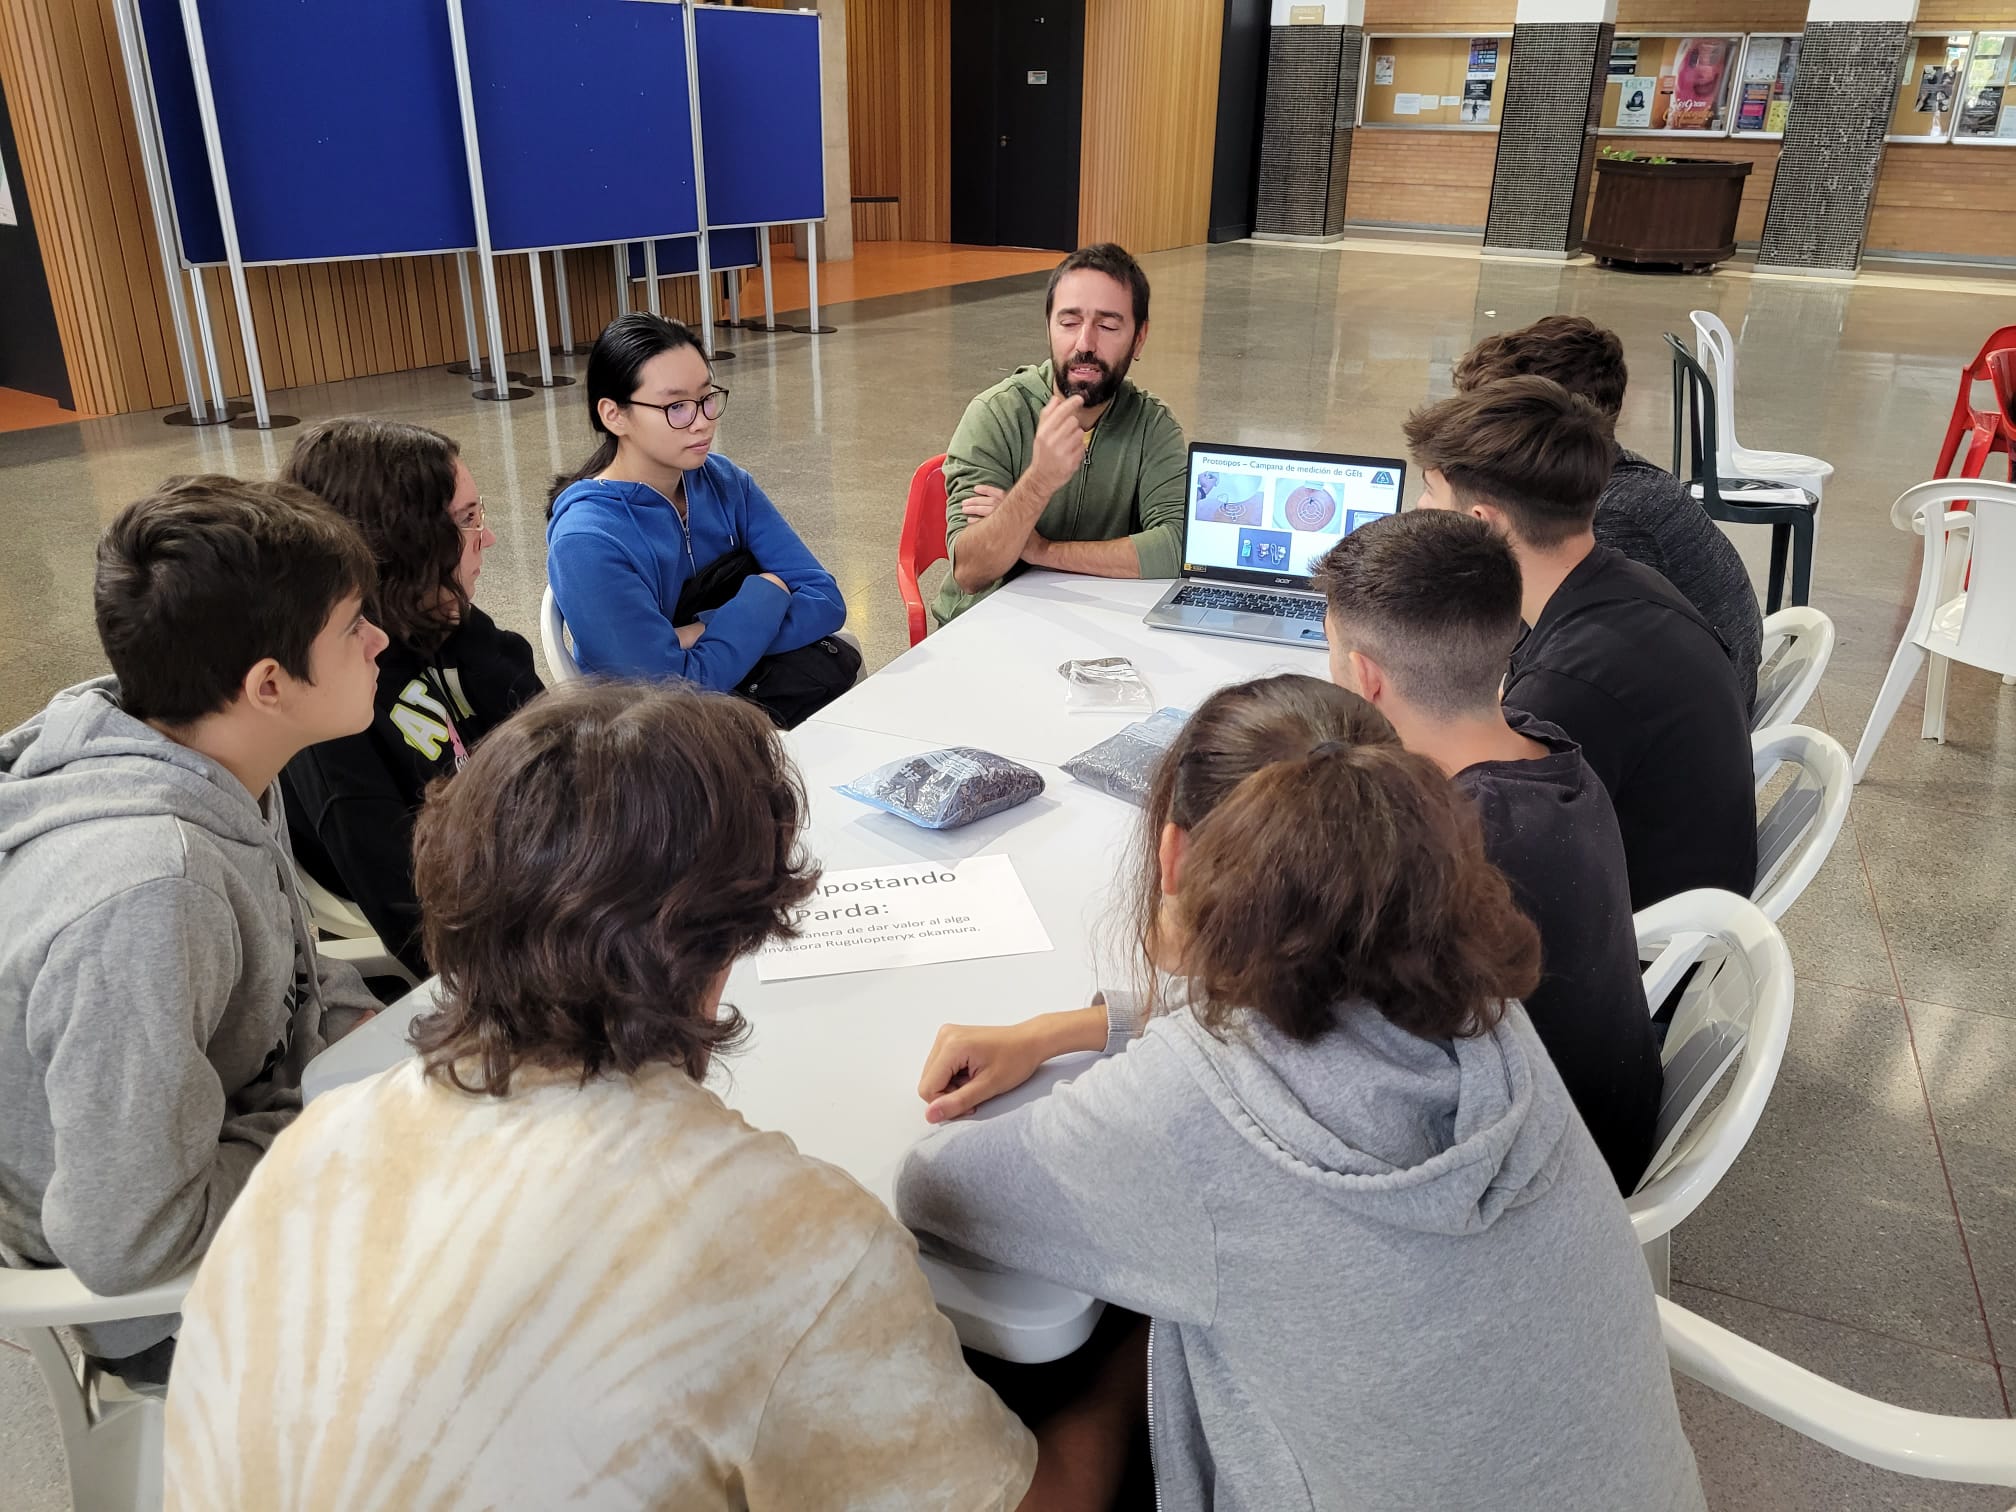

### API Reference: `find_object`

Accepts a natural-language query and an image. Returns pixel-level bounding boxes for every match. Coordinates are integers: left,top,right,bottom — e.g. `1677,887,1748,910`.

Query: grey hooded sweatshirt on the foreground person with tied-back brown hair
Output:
897,994,1704,1512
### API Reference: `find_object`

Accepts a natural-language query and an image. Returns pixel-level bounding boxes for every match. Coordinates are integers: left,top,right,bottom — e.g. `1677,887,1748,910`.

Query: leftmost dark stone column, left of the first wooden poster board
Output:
1254,0,1365,242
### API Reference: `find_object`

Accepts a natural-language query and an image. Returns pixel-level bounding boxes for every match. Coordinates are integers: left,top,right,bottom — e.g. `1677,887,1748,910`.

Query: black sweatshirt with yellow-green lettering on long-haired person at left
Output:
280,605,540,976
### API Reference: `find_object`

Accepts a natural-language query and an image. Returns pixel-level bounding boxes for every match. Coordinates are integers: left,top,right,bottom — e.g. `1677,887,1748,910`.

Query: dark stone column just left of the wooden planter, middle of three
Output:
1484,0,1617,258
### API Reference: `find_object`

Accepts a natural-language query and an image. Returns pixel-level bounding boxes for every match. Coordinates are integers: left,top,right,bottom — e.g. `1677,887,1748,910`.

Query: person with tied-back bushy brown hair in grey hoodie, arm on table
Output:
897,677,1704,1512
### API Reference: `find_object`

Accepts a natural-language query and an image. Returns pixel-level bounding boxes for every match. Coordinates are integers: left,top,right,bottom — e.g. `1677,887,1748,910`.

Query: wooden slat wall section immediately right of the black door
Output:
1079,0,1224,252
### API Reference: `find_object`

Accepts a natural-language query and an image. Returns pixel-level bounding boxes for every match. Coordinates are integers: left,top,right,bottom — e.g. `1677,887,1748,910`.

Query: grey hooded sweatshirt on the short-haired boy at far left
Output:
0,677,377,1357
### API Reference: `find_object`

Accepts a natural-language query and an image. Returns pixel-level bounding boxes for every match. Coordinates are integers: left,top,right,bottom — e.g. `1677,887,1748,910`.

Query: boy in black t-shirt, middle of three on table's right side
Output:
1407,377,1758,909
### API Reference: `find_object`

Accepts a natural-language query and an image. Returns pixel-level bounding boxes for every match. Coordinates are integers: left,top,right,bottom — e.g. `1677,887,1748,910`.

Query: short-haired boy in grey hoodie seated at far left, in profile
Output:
0,478,385,1381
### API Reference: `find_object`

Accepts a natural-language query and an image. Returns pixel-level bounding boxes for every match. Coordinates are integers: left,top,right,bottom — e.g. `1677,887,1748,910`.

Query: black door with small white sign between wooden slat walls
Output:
952,0,1085,252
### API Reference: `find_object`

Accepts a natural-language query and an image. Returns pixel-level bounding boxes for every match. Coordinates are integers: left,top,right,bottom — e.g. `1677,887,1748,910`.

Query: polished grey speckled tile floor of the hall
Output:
0,242,2016,1512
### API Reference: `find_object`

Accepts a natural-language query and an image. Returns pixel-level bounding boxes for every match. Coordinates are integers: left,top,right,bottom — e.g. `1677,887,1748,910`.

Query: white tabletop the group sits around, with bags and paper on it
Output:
304,573,1325,1361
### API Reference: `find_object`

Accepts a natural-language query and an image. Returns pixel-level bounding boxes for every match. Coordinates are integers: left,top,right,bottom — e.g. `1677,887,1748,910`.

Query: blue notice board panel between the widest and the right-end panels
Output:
463,0,700,252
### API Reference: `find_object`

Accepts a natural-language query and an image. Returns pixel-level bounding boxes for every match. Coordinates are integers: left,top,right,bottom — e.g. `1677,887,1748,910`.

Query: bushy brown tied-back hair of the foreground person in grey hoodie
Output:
1137,675,1540,1040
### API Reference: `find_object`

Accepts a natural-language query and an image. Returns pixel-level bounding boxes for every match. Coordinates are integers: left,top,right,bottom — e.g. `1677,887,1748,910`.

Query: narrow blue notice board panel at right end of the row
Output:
694,6,827,226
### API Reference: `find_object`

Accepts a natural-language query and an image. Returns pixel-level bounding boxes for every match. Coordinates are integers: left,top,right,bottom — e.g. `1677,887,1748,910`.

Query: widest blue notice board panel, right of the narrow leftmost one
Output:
183,0,476,262
